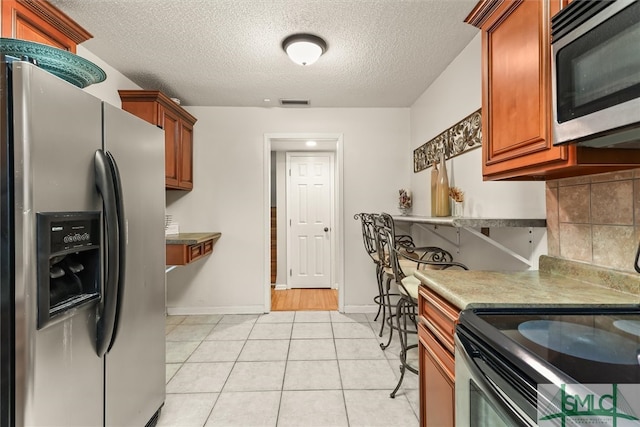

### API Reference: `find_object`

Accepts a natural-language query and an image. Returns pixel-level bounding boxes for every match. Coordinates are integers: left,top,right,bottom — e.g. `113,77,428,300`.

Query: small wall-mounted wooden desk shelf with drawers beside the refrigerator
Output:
165,233,222,265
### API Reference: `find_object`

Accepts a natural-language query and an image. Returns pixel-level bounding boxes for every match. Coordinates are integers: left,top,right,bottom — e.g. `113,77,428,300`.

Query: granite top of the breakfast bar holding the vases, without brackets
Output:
393,215,547,228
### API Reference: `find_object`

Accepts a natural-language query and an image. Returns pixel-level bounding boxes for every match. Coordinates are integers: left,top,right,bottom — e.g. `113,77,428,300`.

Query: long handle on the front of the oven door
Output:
455,333,537,427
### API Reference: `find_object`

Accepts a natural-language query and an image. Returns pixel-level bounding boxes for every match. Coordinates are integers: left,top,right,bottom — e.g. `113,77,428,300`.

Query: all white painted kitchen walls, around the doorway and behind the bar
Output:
78,30,546,313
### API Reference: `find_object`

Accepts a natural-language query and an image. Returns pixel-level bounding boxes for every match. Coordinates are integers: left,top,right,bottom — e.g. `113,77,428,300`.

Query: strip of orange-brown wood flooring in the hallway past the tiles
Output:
271,287,338,311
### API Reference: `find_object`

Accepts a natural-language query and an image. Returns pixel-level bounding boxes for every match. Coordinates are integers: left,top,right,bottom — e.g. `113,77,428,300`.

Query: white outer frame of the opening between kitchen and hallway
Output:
262,133,345,313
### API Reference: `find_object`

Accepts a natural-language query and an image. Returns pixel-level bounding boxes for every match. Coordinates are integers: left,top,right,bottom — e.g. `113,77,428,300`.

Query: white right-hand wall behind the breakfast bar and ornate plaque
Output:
410,34,547,270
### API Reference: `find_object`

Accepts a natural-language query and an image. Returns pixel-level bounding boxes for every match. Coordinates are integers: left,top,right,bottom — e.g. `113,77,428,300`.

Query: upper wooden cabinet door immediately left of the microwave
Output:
482,0,569,177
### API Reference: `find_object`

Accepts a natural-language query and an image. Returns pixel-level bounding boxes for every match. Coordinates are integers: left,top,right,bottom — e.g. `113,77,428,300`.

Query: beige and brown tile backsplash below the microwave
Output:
546,169,640,271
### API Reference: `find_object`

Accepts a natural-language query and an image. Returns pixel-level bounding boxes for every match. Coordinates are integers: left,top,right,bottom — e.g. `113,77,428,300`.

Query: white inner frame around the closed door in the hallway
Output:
286,151,336,289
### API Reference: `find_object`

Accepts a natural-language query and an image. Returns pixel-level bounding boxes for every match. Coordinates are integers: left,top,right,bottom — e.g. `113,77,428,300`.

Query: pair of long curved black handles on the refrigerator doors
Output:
95,150,126,357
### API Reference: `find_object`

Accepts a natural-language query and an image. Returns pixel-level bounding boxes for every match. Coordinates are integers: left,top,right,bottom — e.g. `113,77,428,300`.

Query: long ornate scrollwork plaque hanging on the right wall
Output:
413,109,482,173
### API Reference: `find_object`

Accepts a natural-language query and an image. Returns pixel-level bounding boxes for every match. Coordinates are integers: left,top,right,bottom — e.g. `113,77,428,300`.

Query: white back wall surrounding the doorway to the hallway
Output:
162,107,411,313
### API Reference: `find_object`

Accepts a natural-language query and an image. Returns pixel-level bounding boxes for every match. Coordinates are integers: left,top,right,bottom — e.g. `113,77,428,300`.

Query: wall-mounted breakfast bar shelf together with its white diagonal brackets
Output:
393,215,547,267
